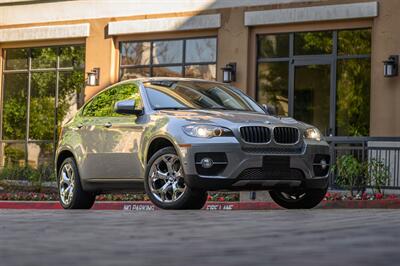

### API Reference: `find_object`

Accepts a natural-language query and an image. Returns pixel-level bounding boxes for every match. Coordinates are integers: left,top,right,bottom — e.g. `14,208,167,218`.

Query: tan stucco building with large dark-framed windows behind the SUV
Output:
0,0,400,167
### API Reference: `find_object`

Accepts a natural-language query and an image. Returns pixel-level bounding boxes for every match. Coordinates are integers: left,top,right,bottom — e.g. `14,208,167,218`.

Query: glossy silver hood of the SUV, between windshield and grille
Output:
160,110,306,127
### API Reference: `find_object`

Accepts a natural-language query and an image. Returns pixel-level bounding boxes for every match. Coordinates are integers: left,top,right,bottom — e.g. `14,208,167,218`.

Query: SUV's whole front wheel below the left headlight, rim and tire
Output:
144,147,207,210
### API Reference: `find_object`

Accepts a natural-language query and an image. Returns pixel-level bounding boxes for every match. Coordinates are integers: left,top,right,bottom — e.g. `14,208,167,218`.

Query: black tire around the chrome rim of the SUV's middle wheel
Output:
144,147,207,210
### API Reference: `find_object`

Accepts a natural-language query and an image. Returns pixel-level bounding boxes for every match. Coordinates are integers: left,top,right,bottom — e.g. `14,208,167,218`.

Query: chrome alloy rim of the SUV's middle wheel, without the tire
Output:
148,154,187,203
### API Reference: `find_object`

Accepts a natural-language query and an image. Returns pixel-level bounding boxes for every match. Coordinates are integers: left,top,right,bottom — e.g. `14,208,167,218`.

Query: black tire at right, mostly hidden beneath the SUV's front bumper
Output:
269,189,327,209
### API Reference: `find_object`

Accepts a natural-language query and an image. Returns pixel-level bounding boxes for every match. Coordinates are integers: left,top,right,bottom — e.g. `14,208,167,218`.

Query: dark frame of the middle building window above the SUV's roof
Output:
118,35,218,81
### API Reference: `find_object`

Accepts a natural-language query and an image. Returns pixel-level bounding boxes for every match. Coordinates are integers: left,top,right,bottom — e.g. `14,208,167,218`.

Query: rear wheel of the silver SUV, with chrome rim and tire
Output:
58,157,96,209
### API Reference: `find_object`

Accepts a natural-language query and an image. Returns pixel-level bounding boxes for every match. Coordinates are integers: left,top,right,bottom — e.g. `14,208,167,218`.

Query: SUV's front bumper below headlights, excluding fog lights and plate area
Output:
181,140,329,190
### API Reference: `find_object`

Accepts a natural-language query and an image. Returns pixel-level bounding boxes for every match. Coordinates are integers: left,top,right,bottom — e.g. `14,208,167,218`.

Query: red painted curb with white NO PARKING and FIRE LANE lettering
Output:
0,199,400,211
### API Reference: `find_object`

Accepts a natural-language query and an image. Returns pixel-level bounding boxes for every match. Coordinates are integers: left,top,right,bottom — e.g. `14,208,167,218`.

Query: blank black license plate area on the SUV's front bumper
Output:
263,156,290,179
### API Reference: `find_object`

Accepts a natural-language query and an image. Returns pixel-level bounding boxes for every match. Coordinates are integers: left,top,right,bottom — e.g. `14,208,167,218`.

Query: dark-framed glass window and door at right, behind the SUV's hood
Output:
256,29,371,136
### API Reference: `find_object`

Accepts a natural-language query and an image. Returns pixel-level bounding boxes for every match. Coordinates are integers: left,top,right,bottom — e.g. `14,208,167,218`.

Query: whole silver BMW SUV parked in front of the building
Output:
55,78,330,209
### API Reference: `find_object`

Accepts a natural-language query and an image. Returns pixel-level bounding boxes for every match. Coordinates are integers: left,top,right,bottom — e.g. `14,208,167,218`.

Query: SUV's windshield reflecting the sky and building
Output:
144,80,264,113
